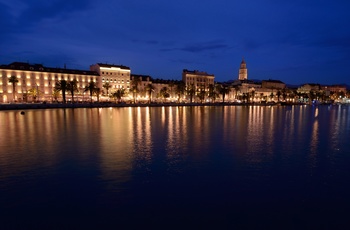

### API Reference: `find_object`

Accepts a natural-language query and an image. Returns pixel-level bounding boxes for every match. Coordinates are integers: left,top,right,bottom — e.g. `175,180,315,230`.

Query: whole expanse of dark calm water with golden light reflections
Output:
0,106,350,229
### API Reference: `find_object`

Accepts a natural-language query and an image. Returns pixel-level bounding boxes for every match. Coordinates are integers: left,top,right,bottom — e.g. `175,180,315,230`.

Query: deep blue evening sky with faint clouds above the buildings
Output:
0,0,350,84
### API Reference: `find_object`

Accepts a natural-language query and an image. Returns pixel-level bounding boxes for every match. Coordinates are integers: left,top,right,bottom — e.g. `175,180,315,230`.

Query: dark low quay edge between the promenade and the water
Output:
0,102,340,111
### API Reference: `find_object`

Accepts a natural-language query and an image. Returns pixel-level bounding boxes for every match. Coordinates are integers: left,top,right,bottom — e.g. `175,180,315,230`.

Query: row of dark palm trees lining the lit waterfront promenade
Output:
9,76,347,103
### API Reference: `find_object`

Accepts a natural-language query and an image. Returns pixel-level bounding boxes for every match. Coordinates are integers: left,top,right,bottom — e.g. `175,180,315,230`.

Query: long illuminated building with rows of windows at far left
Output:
0,62,98,103
